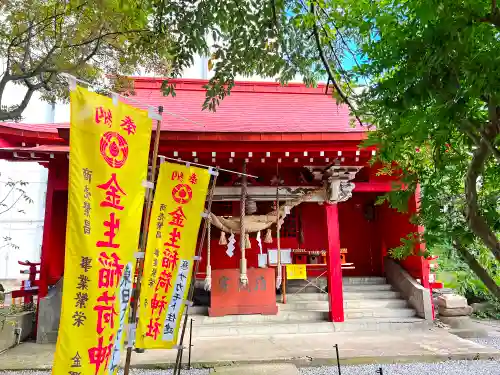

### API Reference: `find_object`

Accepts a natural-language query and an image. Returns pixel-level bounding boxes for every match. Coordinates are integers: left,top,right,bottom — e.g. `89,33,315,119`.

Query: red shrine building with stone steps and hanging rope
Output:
0,77,433,342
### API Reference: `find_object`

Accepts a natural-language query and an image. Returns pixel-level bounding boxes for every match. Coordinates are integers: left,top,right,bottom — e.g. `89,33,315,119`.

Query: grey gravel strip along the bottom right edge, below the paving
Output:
300,361,500,375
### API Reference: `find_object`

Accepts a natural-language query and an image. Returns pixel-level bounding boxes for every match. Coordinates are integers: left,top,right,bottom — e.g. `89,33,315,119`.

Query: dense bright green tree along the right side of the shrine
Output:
316,0,500,298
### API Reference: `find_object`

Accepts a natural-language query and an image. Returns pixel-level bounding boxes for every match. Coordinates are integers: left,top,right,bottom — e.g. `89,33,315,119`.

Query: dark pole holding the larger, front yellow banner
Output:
123,106,163,375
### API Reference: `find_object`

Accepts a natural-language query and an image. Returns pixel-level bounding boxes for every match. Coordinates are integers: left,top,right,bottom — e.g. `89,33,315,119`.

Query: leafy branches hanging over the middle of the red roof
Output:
151,0,360,116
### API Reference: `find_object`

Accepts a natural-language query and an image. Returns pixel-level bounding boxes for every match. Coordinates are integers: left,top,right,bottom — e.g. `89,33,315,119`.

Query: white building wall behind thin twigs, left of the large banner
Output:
0,160,47,280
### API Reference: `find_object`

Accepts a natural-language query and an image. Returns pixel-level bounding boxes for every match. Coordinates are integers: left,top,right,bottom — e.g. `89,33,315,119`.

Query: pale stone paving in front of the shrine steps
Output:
0,329,500,370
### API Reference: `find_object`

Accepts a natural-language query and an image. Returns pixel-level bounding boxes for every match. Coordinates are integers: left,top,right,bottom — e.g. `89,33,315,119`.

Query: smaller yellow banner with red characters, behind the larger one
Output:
135,163,210,349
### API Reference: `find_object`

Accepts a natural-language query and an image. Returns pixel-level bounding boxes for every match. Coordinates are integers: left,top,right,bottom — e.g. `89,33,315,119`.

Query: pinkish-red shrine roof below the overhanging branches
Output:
0,77,366,136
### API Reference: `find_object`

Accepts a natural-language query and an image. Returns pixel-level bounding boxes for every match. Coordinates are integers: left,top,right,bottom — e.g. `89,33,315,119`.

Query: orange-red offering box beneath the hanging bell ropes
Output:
208,268,278,316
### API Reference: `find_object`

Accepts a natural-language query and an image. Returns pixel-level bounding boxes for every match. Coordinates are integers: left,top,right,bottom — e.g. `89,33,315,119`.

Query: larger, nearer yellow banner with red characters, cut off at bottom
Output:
52,87,152,375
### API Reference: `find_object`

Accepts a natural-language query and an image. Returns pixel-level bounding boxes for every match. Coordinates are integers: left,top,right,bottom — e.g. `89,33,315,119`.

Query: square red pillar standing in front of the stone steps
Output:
325,204,344,322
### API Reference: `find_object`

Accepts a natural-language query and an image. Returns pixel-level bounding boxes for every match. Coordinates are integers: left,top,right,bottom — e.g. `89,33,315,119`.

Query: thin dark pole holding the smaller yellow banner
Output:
173,168,219,375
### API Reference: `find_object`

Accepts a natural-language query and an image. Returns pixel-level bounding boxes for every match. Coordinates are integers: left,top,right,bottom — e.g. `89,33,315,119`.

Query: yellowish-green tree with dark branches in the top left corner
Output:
0,0,171,121
